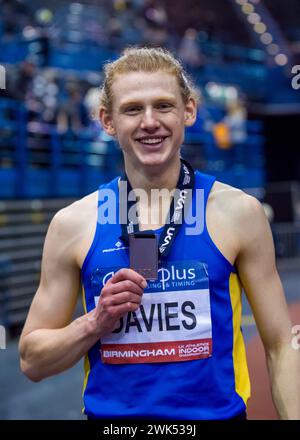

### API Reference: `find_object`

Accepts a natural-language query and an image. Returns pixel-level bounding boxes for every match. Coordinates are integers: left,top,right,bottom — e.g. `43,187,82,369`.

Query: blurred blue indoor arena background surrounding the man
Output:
0,0,300,419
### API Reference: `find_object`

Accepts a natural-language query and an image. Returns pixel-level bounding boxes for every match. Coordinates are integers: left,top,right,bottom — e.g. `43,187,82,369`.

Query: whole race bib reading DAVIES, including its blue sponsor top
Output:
95,261,212,364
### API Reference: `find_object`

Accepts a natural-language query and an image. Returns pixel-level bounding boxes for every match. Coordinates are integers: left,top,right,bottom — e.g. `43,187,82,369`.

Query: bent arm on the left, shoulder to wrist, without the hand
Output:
19,210,97,381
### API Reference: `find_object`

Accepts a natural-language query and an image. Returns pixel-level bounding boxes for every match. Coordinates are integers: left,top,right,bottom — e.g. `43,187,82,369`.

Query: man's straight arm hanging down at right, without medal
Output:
236,195,300,419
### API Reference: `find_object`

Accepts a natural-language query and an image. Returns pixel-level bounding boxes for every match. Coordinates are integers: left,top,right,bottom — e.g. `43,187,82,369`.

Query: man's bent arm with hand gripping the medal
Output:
19,209,144,381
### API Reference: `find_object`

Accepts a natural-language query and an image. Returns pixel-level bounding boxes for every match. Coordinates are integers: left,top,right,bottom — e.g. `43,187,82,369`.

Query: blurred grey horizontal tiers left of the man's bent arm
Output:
0,199,73,334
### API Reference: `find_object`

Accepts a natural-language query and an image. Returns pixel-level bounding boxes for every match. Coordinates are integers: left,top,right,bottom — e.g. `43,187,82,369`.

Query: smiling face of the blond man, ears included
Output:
100,71,196,168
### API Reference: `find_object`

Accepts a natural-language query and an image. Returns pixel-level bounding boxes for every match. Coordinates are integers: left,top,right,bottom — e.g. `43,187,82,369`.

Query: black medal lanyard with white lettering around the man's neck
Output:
119,159,195,257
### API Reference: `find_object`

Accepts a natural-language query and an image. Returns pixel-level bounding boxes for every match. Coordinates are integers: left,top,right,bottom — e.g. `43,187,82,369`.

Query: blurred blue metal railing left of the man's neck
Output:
0,99,122,199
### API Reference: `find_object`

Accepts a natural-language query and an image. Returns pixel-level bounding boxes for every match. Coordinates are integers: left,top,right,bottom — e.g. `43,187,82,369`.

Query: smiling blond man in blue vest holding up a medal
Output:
20,49,300,420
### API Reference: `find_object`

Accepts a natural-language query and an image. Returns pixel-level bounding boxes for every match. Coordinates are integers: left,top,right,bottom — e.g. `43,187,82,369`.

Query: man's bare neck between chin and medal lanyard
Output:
125,156,181,193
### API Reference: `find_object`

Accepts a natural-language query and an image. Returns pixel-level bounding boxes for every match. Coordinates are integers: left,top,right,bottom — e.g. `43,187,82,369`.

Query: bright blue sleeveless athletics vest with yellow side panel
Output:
82,171,250,420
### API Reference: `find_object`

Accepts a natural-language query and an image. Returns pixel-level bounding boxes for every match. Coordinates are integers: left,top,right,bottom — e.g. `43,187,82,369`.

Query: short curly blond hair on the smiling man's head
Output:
100,47,199,111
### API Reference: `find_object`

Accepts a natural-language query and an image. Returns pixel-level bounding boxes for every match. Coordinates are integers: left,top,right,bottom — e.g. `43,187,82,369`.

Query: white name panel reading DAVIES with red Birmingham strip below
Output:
101,289,212,364
